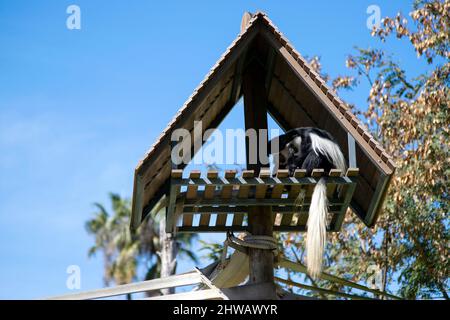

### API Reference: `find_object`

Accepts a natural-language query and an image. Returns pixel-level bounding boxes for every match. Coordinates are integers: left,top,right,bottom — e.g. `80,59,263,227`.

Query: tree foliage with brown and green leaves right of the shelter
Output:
283,0,450,299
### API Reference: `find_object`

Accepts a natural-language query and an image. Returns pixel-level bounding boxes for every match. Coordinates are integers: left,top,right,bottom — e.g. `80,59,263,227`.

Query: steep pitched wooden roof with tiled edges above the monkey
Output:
131,12,395,229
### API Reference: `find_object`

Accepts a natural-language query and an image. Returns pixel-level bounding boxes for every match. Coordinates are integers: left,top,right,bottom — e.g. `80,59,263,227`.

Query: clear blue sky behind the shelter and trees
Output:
0,0,426,298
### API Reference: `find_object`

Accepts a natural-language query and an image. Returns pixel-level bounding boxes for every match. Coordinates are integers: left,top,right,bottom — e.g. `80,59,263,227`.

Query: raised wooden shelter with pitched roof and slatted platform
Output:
131,12,395,298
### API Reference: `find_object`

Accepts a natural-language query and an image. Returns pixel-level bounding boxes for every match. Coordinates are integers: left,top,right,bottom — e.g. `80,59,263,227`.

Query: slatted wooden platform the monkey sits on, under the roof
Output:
166,168,359,232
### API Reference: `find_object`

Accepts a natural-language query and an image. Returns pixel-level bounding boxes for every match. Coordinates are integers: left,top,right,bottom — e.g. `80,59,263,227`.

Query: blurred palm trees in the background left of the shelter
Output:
86,193,197,295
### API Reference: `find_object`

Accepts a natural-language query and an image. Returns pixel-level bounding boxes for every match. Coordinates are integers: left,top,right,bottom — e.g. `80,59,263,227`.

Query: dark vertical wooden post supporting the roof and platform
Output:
242,61,276,299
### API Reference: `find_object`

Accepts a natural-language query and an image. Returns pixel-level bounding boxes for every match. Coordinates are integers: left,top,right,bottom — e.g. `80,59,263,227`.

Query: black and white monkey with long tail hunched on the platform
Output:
268,127,346,278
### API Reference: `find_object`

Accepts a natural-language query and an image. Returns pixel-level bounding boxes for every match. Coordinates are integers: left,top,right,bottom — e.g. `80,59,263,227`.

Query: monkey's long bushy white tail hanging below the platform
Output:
306,178,328,279
